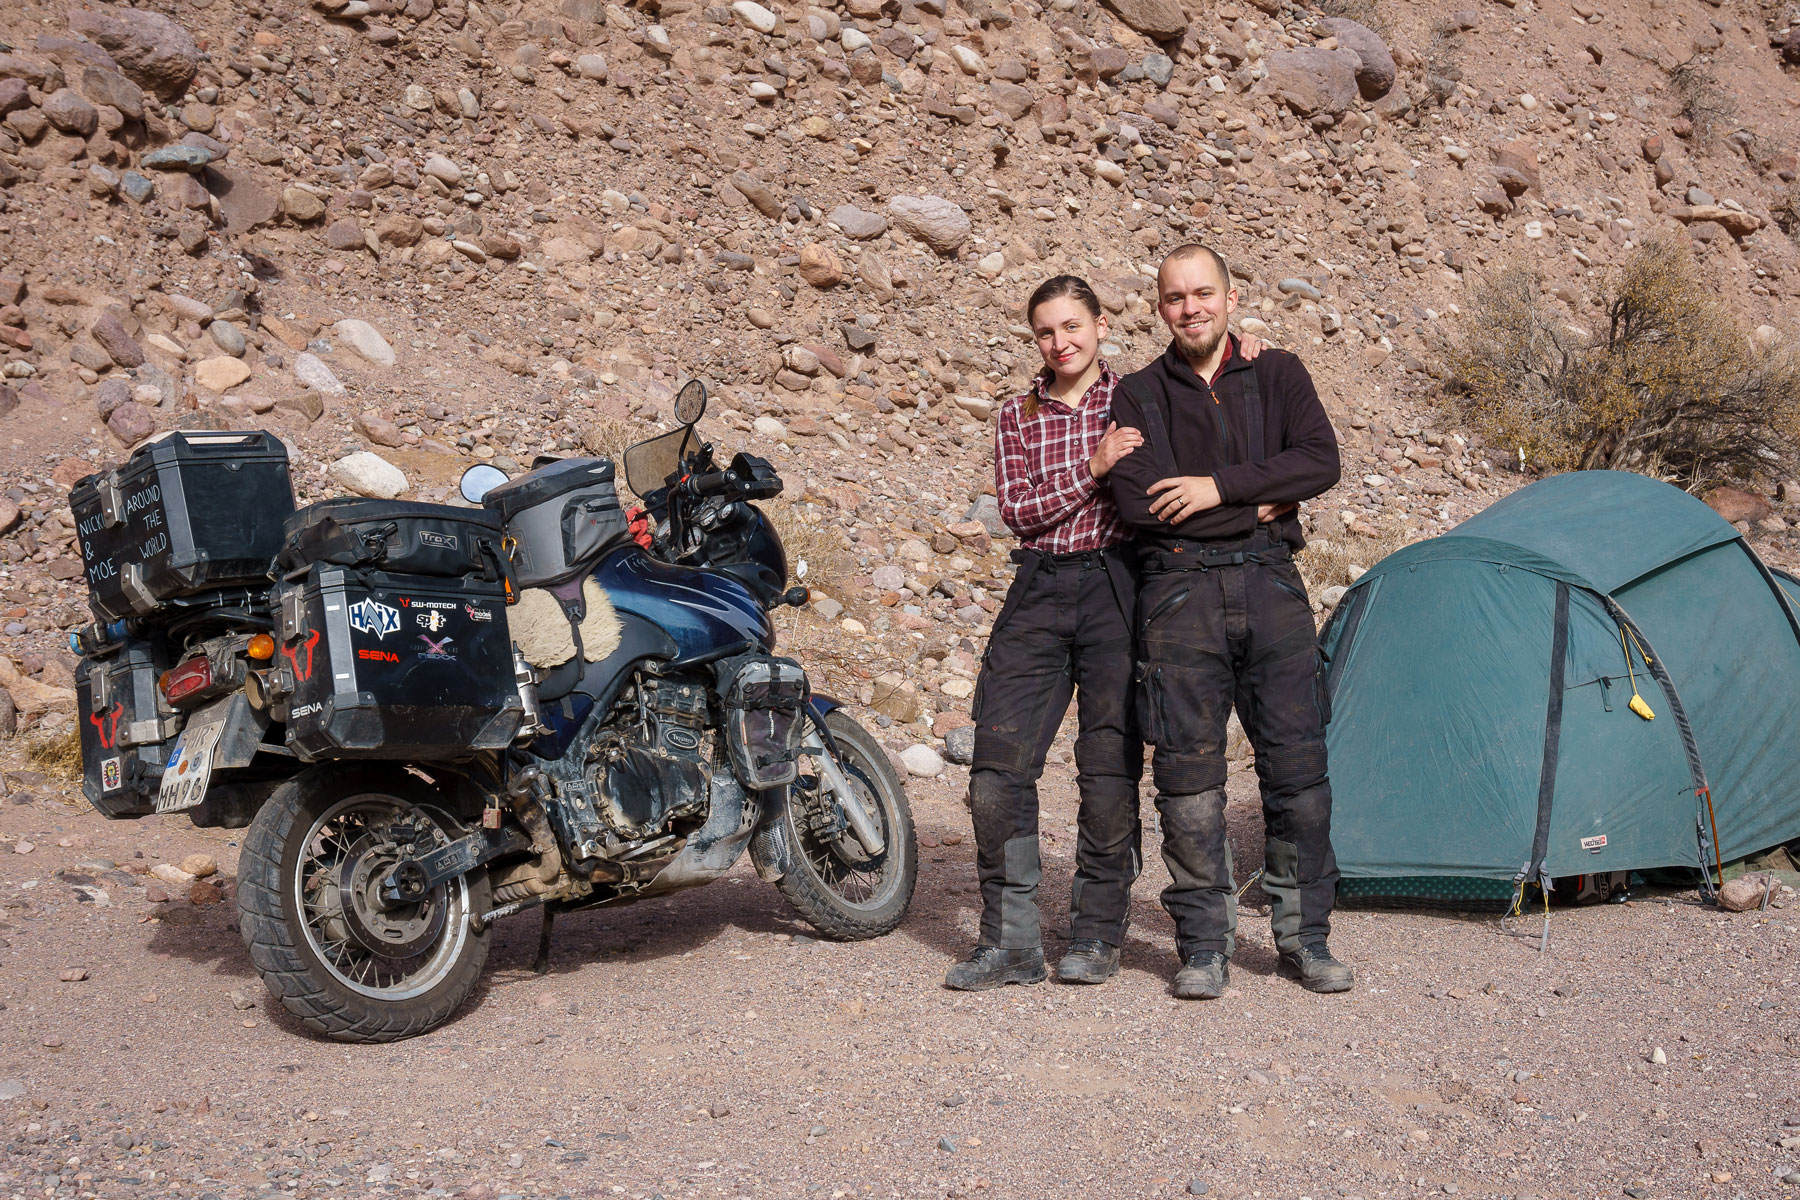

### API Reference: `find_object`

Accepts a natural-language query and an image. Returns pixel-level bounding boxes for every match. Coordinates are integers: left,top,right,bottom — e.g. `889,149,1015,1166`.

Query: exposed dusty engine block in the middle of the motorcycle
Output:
589,678,707,842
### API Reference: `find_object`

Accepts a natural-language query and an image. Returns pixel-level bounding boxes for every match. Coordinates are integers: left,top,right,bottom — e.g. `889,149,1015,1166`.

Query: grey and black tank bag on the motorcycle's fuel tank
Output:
481,459,630,588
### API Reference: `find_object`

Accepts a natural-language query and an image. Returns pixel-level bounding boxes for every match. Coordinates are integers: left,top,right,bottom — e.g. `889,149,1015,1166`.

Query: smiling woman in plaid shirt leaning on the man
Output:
943,275,1262,991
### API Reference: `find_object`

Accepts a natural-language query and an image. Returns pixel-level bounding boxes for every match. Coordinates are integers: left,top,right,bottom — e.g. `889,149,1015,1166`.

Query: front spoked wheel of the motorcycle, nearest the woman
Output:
776,711,918,941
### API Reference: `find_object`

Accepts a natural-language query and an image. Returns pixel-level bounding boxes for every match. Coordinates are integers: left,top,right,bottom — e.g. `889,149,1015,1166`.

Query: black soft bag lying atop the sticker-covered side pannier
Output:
275,497,500,579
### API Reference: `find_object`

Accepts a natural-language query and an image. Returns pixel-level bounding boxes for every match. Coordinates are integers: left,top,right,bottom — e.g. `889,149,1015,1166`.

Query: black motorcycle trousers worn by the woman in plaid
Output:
968,551,1143,950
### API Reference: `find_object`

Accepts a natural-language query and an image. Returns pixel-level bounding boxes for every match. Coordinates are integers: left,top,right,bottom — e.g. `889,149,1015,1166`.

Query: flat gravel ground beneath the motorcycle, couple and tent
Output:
0,750,1800,1200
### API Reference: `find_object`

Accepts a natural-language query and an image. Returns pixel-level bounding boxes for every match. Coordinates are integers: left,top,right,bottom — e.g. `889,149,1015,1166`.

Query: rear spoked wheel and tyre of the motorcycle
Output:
238,765,491,1042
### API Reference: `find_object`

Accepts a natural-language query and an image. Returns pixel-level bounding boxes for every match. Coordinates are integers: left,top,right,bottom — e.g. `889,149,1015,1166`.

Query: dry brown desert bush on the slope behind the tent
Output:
1445,236,1800,489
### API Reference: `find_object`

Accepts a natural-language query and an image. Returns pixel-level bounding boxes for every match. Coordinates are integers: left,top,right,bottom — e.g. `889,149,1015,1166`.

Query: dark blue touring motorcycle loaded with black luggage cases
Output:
72,381,918,1042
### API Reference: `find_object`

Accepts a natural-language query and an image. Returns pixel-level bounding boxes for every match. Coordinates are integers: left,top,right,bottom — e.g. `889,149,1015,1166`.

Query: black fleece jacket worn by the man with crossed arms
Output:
1109,338,1343,551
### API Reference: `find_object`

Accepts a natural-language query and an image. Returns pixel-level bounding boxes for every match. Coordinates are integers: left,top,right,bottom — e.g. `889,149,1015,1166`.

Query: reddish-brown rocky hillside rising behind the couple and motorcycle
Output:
0,0,1800,770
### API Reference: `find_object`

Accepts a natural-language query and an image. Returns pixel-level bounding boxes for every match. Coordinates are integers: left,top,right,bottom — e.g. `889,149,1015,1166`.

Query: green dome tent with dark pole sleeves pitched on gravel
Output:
1321,471,1800,900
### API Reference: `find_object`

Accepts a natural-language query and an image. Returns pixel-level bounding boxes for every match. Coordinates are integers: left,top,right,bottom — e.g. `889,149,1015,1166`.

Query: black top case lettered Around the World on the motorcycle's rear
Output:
68,430,293,621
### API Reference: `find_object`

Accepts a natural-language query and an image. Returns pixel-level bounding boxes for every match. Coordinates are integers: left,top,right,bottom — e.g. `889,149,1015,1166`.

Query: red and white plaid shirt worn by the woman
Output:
994,362,1129,554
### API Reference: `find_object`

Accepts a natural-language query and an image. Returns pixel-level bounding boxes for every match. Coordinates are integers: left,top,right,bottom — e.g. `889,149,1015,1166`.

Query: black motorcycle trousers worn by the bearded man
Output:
1138,533,1337,961
